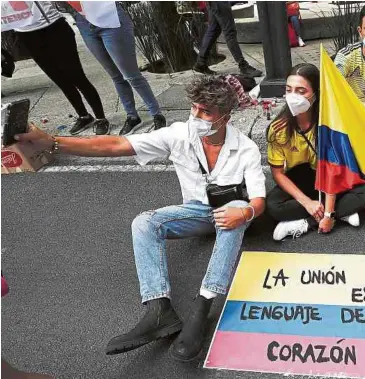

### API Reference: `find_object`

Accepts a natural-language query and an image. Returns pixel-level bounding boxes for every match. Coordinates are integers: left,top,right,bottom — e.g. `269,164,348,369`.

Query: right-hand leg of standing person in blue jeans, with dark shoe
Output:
100,5,166,133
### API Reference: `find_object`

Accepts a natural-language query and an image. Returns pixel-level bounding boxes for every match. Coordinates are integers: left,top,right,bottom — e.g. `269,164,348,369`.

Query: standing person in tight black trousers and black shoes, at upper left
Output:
14,1,110,135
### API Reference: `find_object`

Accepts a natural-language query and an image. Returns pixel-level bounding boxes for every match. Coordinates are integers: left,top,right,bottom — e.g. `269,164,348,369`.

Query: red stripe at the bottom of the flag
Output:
315,160,365,194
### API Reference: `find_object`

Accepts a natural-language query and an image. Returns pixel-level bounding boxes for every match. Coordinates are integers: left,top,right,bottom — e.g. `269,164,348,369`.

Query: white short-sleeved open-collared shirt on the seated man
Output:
126,122,266,204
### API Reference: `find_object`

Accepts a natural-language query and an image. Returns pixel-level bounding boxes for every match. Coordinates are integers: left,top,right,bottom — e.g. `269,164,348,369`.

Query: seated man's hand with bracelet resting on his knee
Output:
213,205,255,230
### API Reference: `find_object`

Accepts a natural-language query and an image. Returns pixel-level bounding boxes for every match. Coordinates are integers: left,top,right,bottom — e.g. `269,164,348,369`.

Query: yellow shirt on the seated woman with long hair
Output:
267,120,317,171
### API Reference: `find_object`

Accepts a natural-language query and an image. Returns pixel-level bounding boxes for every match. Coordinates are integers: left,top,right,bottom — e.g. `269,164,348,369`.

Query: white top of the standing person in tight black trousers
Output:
14,1,63,32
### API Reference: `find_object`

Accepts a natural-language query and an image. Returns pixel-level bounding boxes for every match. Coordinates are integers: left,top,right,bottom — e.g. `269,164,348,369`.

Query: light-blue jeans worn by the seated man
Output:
132,200,250,302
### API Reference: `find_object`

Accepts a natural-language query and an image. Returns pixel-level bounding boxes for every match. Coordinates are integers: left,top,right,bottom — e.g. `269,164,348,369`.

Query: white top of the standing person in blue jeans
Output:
80,1,120,28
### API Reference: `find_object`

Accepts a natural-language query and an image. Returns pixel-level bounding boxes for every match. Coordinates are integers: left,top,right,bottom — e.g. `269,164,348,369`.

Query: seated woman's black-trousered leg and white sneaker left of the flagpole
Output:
266,164,318,241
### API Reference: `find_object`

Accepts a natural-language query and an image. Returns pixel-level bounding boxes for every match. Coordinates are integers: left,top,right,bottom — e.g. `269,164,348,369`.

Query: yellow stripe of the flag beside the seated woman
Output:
319,45,365,173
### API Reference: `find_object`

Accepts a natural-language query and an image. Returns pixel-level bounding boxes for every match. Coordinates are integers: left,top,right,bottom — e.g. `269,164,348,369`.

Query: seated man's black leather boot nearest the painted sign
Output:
170,295,213,362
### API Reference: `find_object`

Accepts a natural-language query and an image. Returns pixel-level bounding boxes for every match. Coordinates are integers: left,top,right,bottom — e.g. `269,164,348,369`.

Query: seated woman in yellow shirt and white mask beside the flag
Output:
266,63,365,241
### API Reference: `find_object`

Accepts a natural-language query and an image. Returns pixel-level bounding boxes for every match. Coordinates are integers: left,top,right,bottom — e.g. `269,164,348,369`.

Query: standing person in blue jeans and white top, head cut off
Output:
68,1,166,135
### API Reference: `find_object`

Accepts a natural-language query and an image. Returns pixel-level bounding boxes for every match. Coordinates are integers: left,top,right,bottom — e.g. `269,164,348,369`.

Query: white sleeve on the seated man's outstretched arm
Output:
125,128,172,166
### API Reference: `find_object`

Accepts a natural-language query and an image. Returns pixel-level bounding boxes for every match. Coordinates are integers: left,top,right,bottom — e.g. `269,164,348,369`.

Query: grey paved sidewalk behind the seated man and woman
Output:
1,14,333,167
